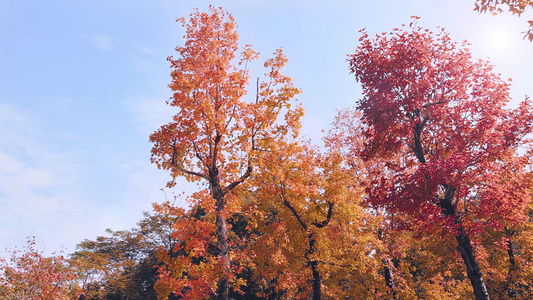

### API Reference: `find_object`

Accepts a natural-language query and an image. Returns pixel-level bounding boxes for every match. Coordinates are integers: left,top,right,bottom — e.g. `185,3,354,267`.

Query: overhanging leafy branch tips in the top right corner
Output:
474,0,533,41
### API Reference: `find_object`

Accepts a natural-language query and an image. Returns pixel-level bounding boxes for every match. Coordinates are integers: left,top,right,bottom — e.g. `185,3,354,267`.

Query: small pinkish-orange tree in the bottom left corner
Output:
0,237,82,300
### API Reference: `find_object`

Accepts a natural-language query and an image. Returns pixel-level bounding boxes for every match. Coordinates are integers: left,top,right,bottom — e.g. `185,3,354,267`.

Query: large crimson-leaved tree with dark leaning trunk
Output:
348,22,533,299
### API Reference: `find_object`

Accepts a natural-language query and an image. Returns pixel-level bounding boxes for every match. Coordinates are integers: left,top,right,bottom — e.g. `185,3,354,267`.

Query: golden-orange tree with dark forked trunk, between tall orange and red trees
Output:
250,145,334,300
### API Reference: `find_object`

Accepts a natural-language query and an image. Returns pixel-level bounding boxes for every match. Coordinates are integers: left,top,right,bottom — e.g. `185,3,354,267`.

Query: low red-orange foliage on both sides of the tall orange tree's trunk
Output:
155,194,273,300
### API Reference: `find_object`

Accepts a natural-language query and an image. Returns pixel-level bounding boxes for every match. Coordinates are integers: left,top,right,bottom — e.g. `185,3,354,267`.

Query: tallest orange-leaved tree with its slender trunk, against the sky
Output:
150,6,303,299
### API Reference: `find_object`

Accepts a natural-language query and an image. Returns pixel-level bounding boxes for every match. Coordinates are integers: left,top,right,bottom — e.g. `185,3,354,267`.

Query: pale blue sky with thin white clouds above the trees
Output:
0,0,533,253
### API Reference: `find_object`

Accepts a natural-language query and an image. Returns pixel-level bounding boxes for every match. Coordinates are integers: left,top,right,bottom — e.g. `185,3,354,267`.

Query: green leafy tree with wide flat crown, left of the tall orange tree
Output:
70,203,176,300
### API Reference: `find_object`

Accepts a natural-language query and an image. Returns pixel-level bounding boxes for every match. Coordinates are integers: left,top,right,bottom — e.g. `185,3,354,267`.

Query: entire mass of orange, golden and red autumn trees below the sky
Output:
0,5,533,300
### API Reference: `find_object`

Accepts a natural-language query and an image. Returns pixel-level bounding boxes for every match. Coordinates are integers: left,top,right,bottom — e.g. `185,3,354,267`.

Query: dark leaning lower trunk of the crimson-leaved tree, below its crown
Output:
455,223,490,300
